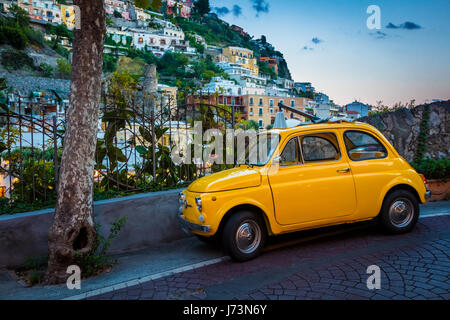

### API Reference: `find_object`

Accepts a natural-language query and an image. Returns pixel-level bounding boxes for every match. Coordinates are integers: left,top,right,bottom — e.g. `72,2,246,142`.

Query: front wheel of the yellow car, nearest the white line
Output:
222,211,267,262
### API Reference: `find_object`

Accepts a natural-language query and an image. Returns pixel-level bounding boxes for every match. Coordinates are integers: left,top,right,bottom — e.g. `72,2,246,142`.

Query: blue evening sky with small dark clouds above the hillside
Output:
210,0,450,106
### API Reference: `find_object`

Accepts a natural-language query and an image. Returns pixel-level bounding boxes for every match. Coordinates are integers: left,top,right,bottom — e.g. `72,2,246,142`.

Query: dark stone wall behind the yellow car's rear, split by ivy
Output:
360,100,450,162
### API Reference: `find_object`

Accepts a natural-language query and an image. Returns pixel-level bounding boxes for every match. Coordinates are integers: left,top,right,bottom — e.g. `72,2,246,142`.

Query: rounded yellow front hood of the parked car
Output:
188,168,261,193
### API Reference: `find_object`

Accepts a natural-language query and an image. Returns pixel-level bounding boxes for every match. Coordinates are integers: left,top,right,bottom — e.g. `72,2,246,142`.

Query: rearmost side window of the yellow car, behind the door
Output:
344,131,387,161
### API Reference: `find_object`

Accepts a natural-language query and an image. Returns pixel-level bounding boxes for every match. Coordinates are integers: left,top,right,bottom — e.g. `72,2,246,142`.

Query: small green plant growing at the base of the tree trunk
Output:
75,217,127,278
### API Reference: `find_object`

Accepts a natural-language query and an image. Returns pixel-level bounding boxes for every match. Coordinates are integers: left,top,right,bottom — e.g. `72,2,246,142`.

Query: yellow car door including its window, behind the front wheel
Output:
269,132,356,225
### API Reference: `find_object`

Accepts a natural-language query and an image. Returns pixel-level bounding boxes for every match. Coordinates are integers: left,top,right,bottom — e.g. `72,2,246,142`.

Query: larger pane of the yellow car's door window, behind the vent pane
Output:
301,133,341,163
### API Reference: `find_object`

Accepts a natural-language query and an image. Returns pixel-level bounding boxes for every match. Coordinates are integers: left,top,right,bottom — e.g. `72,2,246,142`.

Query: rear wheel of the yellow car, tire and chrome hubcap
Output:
379,190,420,234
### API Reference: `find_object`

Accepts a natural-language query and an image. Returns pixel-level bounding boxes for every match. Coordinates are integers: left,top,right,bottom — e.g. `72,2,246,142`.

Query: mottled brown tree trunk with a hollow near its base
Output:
46,0,106,284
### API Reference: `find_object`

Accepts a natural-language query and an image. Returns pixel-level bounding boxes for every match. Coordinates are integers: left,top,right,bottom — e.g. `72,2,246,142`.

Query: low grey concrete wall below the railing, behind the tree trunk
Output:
0,190,187,267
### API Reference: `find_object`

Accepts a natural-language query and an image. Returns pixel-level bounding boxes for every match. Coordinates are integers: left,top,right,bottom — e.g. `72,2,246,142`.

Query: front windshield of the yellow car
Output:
238,133,280,166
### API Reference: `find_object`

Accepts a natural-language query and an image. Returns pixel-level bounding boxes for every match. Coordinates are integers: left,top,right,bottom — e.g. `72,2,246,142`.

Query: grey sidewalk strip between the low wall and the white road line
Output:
0,201,450,300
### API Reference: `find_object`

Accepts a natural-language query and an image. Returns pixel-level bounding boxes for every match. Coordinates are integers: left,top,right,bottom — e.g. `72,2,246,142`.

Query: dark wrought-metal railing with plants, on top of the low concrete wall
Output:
0,90,239,212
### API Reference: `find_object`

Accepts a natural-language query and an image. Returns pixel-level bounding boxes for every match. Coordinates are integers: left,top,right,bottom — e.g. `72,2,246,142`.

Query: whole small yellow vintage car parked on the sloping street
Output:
180,122,429,261
